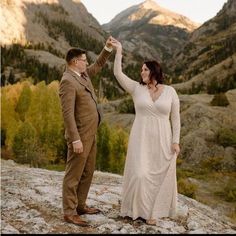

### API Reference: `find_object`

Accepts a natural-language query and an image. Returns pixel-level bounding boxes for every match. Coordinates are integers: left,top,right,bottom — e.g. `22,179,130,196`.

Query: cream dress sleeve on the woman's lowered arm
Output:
170,88,180,143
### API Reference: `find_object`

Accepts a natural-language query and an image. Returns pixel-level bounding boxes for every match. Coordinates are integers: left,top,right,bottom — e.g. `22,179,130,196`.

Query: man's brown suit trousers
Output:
62,135,97,215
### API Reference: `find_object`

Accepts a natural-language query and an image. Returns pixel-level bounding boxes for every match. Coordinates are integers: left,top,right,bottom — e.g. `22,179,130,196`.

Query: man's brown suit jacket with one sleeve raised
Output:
59,49,111,143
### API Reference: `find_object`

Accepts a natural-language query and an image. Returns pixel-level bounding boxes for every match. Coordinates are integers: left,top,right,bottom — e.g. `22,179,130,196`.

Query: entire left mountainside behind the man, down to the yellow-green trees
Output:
0,0,114,90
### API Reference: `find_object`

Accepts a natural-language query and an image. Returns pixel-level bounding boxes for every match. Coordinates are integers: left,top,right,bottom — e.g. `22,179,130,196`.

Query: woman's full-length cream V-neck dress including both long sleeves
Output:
114,52,180,220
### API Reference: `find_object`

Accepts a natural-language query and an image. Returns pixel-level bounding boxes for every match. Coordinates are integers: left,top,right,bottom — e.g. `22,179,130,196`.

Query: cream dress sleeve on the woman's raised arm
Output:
114,52,138,94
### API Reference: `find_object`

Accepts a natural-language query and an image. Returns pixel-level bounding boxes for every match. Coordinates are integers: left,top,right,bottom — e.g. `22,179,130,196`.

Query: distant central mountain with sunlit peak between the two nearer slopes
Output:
103,0,199,61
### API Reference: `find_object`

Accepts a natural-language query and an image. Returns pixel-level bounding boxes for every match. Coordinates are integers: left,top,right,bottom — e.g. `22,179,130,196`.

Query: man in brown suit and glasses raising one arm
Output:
59,37,112,226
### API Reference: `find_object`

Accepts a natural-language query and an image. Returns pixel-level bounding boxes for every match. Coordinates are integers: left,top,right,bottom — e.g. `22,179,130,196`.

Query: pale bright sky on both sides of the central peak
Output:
81,0,227,25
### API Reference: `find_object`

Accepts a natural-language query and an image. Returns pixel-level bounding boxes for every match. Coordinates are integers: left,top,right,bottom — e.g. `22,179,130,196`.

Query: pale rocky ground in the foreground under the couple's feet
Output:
1,160,236,234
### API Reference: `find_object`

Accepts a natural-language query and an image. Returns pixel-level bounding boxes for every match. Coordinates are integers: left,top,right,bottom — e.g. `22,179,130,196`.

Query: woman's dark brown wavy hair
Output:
140,60,164,85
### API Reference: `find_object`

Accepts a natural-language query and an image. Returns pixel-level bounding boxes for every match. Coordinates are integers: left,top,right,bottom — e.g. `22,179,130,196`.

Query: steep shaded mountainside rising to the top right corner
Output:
167,0,236,82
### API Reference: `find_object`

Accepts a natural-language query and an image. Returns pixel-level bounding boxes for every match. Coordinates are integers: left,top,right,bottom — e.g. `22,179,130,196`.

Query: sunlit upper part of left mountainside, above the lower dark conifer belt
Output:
0,0,105,53
